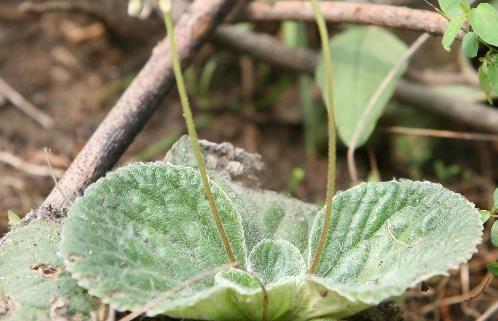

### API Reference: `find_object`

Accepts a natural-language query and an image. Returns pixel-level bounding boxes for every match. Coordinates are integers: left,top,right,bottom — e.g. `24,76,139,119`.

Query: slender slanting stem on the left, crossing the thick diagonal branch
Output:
163,11,237,264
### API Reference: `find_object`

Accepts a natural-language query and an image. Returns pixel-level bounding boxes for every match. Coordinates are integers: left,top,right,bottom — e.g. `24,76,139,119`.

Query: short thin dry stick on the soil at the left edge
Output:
0,77,55,128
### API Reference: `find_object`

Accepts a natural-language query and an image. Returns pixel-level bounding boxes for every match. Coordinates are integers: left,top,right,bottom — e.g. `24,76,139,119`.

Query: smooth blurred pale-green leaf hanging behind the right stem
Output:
316,26,407,146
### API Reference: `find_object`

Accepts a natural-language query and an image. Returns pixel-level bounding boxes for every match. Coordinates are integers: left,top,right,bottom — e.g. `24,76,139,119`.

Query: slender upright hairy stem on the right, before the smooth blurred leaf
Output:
310,0,336,274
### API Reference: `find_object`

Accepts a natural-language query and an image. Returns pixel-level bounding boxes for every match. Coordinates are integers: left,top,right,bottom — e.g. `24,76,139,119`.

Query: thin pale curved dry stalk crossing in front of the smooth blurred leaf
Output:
347,33,430,185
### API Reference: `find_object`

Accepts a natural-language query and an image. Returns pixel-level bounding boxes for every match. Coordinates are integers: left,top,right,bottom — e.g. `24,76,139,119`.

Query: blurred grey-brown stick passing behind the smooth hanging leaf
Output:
214,26,498,134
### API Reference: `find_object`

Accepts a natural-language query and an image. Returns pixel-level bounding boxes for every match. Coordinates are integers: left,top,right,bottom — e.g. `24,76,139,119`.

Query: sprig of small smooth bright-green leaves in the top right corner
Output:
439,0,498,100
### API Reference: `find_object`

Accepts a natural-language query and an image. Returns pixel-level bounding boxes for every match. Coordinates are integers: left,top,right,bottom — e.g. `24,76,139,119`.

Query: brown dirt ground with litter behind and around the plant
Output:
0,0,498,321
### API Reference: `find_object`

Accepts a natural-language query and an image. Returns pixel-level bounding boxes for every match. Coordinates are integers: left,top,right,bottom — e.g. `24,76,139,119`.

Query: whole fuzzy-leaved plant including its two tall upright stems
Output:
0,0,488,321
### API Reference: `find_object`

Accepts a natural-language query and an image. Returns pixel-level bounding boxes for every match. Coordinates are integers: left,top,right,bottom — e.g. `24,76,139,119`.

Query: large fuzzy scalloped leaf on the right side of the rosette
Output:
309,180,483,304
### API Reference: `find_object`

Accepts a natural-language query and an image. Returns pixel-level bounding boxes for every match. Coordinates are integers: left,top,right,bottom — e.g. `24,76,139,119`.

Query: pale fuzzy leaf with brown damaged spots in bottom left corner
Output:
0,221,101,321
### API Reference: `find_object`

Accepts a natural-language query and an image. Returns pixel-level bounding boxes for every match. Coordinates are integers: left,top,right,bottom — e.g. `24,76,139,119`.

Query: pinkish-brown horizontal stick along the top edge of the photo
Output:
238,1,448,35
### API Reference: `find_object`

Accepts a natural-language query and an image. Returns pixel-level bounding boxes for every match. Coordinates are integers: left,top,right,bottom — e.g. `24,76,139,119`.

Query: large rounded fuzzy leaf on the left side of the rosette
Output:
61,162,246,310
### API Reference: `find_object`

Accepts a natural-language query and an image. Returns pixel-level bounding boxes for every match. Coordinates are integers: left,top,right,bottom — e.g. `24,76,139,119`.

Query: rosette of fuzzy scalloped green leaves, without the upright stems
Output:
61,163,482,321
